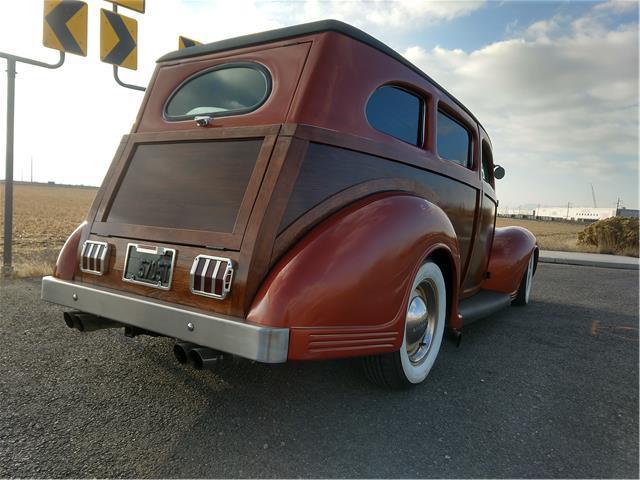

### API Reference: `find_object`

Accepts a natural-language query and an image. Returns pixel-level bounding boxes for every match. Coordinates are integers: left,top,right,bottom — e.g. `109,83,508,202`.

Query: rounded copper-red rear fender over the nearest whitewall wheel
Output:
247,193,459,358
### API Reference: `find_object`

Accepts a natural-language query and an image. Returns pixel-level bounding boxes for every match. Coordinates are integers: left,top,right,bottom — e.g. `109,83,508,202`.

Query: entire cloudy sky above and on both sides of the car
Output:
0,0,638,208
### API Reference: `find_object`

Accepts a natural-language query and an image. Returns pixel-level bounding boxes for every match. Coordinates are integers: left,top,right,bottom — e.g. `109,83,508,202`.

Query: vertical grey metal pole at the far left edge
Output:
2,58,16,275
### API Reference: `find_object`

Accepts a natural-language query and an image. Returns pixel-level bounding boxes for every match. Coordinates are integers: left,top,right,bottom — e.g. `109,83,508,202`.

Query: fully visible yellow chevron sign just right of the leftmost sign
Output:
100,9,138,70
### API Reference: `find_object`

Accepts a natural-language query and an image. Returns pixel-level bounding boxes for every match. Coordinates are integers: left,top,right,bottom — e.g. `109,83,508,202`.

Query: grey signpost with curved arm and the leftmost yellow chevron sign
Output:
0,0,88,275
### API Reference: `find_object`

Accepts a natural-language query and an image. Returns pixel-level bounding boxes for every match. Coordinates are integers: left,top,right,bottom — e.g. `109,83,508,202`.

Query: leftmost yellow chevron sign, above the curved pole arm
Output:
42,0,88,57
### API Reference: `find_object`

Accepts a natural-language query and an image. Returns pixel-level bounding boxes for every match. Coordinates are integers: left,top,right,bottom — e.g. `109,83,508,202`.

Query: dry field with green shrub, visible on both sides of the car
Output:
0,184,638,277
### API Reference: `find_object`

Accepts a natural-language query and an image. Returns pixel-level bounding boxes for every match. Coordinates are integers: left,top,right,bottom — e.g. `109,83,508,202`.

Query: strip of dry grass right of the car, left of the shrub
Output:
496,217,598,253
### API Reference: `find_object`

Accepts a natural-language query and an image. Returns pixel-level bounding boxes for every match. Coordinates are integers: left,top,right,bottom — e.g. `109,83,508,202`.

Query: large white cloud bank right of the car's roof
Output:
404,4,638,205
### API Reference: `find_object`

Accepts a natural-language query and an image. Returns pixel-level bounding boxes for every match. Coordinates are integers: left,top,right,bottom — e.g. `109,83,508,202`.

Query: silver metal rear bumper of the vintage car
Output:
42,276,289,363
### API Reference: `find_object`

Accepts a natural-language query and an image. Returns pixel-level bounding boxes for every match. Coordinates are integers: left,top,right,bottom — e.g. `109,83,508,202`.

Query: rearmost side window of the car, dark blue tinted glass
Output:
366,86,424,146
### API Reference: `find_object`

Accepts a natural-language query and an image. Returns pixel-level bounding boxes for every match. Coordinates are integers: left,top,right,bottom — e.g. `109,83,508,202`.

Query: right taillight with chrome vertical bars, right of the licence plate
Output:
189,255,233,299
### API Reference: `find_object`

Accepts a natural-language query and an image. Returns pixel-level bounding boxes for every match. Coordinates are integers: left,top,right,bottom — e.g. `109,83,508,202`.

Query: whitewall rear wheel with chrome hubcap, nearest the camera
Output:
363,261,447,388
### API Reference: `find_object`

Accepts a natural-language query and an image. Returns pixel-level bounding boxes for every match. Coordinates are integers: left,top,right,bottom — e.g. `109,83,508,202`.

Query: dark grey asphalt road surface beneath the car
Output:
0,264,638,478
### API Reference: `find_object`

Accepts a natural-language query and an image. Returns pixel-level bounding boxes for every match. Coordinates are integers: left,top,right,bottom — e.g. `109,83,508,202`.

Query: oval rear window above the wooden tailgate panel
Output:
165,64,271,120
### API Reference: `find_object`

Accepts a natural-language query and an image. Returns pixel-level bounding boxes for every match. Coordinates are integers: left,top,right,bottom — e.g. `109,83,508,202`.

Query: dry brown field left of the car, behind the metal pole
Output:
0,184,97,277
